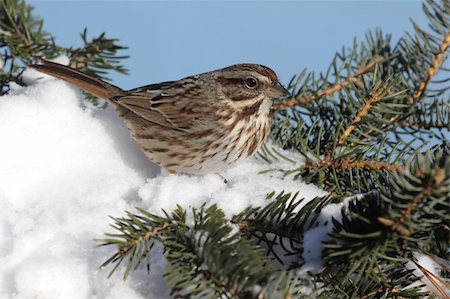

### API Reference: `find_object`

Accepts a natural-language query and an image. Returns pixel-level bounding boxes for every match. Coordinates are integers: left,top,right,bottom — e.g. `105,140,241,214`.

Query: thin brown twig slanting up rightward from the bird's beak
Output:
272,56,384,110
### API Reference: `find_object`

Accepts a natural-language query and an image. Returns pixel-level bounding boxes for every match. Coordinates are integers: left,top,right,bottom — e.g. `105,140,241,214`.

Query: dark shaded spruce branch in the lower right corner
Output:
324,148,450,296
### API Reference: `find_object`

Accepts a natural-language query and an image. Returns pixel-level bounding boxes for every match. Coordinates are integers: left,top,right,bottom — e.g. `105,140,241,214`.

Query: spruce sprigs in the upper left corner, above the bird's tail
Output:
0,0,128,104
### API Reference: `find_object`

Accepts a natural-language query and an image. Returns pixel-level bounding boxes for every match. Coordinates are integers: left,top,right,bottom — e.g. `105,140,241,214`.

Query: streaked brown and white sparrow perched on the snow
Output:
31,62,289,174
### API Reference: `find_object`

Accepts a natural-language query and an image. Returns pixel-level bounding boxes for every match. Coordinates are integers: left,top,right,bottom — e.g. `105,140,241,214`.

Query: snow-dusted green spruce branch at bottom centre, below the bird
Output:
99,205,288,298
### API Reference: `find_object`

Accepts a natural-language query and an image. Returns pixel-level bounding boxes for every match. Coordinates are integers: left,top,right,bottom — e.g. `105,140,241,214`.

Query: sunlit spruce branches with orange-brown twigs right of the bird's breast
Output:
272,1,450,195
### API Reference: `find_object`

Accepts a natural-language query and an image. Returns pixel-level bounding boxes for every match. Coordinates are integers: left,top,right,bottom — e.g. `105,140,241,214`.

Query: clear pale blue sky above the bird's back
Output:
28,0,426,89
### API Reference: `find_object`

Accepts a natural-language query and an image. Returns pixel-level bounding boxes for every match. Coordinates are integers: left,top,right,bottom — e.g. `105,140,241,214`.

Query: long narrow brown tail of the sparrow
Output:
29,61,124,106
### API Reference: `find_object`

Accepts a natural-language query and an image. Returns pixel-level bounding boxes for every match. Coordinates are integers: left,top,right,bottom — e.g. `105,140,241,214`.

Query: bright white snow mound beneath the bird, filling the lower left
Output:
0,76,328,299
